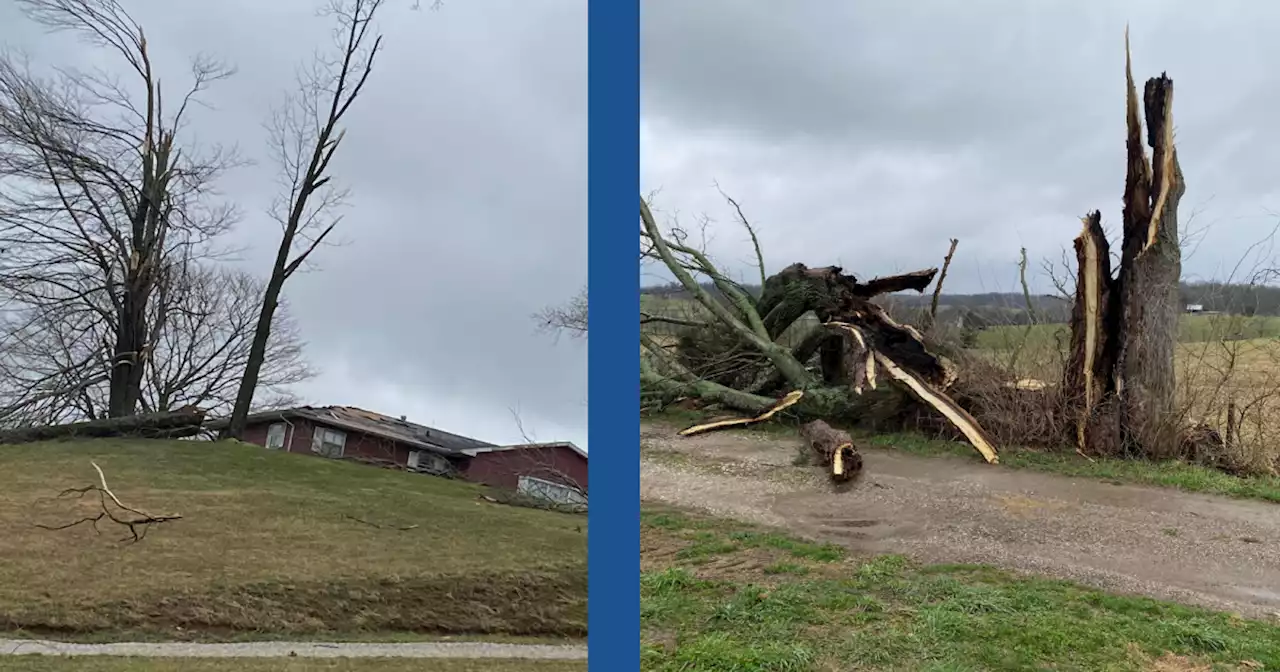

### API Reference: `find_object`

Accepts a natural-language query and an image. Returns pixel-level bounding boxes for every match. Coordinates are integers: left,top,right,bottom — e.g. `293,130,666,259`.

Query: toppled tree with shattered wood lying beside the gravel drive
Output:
640,198,998,462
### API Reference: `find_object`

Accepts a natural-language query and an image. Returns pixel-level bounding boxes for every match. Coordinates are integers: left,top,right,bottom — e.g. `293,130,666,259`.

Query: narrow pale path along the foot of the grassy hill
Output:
0,639,586,660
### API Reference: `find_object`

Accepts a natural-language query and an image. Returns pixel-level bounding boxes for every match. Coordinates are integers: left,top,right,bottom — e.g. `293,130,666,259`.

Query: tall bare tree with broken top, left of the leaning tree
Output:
0,0,236,417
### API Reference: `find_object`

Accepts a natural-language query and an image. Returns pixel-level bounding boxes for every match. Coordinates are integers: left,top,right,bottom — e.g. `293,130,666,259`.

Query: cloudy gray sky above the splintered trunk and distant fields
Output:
640,0,1280,293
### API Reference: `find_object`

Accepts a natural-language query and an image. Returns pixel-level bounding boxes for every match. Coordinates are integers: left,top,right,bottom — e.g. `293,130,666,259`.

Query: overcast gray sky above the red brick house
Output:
0,0,588,447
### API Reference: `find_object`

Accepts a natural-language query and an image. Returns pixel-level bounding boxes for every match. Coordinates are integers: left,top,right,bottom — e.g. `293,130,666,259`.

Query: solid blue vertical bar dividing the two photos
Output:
588,0,640,672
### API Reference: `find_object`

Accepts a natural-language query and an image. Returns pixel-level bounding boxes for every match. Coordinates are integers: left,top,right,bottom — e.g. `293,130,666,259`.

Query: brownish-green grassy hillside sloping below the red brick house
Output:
0,440,586,639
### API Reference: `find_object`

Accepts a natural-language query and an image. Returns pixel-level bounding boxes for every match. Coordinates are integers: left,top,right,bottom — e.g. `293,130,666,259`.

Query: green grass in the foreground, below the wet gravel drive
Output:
640,507,1280,672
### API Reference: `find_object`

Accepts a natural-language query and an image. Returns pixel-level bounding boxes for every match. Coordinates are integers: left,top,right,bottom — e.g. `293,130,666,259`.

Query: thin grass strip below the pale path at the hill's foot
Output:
0,655,586,672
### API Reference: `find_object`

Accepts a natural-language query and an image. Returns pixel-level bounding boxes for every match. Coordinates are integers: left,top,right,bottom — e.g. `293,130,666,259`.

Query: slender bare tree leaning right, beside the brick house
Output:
223,0,384,438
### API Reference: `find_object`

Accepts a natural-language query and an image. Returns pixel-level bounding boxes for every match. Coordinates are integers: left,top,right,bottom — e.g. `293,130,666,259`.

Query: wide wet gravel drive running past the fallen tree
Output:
640,422,1280,617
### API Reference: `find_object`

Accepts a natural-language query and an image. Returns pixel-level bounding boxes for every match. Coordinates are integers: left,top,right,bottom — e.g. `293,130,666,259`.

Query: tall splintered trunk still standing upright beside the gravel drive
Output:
1064,44,1185,458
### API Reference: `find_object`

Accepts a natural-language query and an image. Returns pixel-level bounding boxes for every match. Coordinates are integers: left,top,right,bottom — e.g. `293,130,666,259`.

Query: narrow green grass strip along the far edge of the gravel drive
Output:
643,410,1280,503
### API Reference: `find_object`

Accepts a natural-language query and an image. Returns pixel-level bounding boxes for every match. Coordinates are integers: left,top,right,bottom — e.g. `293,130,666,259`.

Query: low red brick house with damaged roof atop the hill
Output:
207,406,588,503
